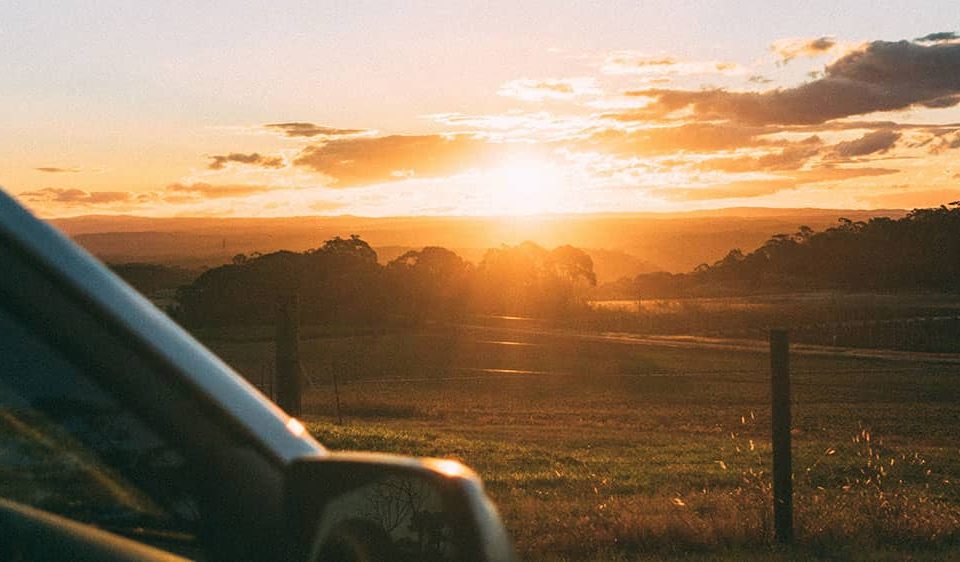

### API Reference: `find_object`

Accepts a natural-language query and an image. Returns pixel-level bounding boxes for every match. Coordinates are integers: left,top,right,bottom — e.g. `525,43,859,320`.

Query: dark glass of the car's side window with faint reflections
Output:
0,302,200,554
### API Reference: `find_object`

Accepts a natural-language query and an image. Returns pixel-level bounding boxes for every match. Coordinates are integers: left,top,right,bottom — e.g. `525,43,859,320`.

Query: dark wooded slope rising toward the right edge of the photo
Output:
632,201,960,298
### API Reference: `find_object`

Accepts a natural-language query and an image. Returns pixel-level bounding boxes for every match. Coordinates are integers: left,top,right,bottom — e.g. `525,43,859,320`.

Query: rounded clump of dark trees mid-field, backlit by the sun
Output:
172,235,596,326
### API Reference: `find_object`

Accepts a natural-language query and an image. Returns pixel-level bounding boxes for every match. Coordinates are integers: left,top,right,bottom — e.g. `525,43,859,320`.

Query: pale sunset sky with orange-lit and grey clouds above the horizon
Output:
0,0,960,217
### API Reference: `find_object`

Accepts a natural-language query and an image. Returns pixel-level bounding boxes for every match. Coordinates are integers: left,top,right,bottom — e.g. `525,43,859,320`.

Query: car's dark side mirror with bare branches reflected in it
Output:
285,453,515,562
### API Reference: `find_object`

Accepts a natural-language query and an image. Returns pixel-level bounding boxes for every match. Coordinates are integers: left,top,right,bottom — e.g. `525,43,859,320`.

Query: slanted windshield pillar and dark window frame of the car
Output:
0,193,325,560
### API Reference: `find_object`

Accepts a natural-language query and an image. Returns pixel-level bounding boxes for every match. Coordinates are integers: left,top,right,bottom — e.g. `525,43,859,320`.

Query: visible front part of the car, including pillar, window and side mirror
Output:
0,190,514,561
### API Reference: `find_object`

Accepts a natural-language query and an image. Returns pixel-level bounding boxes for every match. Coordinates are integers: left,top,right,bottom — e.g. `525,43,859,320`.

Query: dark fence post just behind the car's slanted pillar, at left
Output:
275,293,302,417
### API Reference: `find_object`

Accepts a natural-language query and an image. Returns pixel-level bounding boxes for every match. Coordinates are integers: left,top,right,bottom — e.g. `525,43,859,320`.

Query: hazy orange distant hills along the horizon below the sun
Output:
50,207,906,274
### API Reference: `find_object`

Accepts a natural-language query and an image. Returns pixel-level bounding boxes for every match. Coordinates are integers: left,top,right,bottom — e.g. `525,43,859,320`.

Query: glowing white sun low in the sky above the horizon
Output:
489,159,563,215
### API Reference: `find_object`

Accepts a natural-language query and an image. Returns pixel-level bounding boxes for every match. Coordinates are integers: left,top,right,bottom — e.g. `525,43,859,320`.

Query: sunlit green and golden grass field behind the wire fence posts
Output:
204,327,960,560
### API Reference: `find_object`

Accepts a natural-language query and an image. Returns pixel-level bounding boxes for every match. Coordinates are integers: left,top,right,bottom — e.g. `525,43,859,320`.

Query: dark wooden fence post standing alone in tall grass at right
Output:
770,330,793,544
